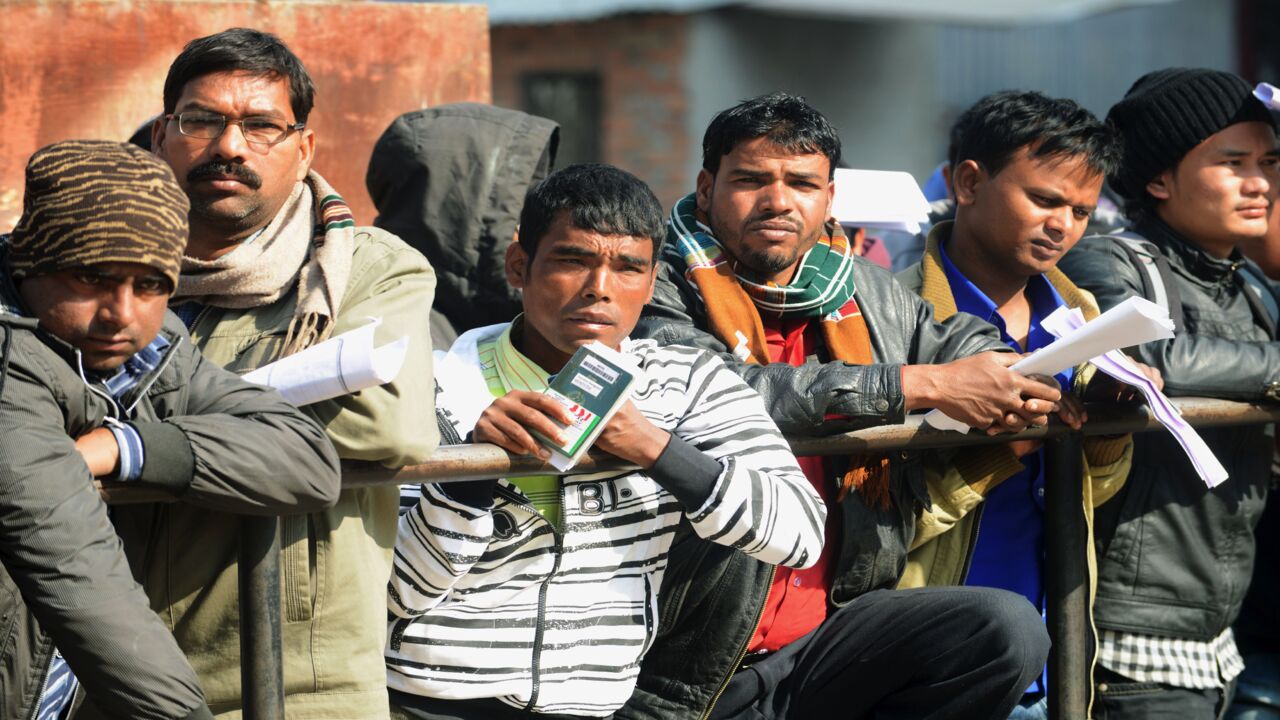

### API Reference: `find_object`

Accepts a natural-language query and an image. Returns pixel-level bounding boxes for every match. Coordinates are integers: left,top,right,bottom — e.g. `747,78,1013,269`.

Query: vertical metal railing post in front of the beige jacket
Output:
239,516,284,720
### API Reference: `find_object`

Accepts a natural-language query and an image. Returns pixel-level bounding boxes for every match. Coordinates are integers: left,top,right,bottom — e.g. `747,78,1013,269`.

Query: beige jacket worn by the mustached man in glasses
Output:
102,228,439,720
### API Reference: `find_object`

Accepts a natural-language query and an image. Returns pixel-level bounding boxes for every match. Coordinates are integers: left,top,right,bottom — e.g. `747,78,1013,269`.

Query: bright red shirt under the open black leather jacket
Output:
746,318,836,652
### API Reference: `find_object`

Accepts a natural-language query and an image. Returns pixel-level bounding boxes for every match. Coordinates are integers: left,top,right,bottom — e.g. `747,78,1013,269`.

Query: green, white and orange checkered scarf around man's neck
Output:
666,195,891,509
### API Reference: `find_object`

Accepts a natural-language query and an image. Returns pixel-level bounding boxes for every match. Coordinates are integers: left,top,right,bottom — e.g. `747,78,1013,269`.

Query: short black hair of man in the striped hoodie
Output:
518,163,666,260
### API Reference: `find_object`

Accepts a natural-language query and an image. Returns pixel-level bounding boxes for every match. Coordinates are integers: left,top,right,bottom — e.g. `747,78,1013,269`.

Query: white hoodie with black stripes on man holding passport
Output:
387,325,826,716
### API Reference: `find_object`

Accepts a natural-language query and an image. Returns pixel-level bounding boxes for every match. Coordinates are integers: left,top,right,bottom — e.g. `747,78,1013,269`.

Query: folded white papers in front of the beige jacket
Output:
244,318,408,406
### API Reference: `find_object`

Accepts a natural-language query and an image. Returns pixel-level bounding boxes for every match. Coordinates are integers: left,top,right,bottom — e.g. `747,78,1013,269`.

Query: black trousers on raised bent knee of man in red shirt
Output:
712,588,1050,720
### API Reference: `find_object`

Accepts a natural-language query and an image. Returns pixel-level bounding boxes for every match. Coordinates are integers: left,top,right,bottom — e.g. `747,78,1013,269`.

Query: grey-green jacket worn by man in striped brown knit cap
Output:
0,246,339,720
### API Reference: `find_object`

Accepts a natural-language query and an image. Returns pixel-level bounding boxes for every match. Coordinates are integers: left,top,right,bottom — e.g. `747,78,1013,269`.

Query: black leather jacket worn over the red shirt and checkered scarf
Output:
616,250,1009,720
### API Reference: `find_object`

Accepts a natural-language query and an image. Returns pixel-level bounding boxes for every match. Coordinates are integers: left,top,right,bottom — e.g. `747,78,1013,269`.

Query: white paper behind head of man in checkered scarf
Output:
831,168,929,234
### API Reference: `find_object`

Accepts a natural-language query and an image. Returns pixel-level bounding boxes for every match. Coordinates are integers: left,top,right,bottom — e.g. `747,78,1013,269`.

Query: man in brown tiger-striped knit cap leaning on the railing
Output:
0,141,338,719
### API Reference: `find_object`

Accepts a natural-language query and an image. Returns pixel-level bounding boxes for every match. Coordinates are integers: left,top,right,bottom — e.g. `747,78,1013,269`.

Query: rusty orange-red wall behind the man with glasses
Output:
0,0,490,226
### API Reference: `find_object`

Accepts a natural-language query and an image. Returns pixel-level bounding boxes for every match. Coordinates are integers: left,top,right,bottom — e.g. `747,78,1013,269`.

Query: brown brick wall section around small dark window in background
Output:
489,14,695,208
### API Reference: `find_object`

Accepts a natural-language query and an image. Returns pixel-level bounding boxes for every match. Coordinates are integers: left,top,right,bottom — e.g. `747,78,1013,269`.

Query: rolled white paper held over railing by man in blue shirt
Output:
924,297,1174,433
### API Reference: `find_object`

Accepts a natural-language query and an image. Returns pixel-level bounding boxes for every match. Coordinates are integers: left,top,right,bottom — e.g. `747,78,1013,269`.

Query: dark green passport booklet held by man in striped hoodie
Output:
534,342,640,471
